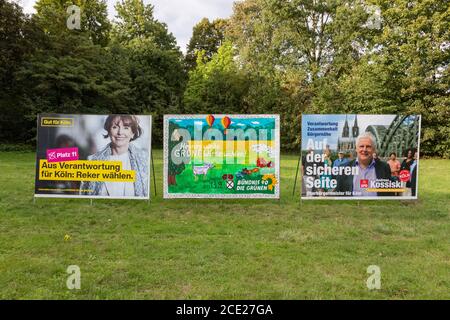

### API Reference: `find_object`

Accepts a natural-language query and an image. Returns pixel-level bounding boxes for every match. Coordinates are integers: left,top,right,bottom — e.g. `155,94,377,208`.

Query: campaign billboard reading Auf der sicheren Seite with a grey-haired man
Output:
301,114,421,200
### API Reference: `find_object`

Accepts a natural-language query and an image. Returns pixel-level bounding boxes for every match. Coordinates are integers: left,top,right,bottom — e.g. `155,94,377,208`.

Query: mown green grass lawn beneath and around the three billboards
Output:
0,150,450,299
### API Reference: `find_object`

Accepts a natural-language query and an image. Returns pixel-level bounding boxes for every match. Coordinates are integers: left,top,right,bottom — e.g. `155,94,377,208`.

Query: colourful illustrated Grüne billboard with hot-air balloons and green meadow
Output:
164,114,280,198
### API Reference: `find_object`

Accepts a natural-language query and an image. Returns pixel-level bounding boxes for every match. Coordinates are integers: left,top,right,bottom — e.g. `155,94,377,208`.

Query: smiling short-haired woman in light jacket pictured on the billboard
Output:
80,115,149,197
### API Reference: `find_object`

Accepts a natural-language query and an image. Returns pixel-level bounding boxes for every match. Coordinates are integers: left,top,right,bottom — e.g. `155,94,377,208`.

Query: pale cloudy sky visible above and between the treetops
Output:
16,0,234,53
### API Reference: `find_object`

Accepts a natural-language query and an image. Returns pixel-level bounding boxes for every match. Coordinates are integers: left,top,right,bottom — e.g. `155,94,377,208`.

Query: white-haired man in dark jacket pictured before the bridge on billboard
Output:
335,132,393,197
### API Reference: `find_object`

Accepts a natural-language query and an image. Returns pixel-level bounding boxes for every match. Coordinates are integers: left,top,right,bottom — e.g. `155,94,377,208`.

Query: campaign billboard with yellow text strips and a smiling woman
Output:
35,114,151,199
